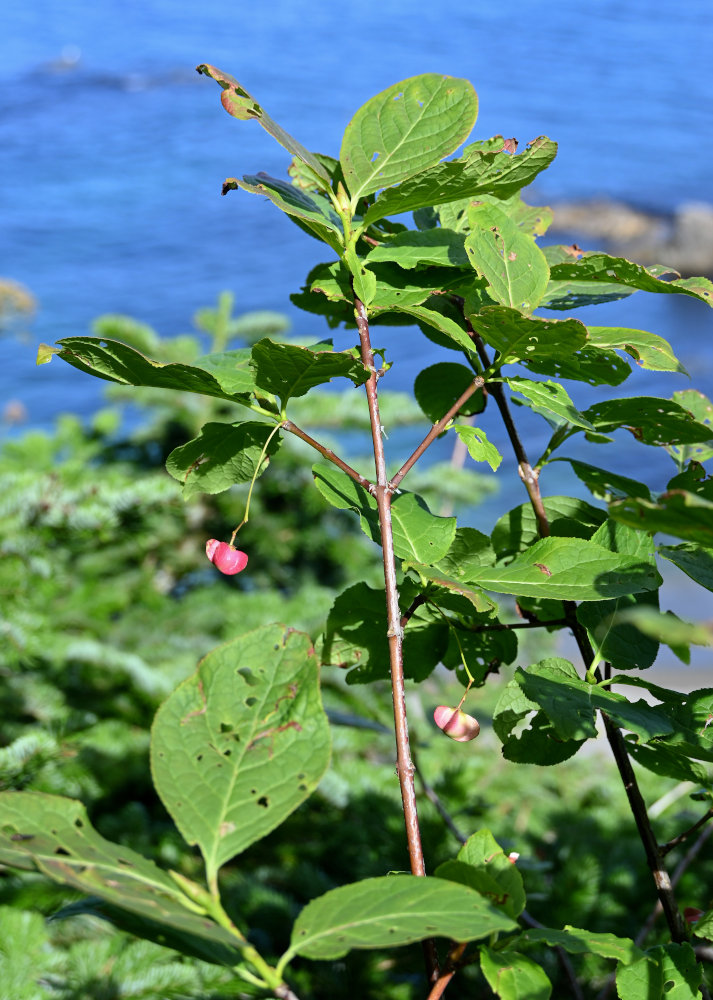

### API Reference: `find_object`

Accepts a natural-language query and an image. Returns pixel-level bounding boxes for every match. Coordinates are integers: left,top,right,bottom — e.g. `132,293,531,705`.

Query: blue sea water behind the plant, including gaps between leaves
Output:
0,0,713,672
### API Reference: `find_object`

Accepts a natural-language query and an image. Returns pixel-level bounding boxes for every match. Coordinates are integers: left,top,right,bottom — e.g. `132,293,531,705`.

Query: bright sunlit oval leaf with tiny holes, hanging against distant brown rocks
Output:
465,204,550,313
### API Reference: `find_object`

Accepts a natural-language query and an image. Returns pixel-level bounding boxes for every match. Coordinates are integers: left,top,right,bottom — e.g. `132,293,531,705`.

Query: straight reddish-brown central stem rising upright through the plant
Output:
354,294,439,983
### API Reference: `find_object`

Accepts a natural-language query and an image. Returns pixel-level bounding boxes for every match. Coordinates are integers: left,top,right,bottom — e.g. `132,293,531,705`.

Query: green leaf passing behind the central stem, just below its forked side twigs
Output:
312,463,456,565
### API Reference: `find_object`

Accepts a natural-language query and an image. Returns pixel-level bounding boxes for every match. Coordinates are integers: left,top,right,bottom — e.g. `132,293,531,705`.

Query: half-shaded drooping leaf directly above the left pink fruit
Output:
166,422,280,500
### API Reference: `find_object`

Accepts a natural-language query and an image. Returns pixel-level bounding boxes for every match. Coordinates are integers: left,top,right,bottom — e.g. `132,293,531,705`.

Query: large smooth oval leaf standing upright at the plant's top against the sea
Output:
339,73,478,205
